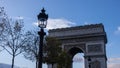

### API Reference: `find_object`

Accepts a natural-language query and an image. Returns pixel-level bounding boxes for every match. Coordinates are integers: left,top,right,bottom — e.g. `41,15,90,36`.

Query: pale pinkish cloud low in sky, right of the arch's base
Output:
108,58,120,68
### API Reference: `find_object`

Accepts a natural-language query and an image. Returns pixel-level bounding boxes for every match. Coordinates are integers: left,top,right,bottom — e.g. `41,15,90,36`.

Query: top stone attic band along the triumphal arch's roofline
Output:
49,24,107,43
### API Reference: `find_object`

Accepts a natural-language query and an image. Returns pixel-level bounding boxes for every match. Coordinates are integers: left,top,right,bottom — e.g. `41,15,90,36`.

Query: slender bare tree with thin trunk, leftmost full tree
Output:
2,21,27,68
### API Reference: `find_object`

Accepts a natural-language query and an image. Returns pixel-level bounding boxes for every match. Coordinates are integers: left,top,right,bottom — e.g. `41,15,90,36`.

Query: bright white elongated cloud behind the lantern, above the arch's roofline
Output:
34,18,76,29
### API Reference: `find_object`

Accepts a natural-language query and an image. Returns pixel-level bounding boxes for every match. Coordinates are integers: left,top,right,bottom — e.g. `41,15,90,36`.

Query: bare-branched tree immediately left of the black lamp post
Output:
22,31,39,68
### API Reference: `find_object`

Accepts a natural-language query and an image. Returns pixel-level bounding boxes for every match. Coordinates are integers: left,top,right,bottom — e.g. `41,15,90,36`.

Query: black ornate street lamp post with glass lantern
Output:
37,8,48,68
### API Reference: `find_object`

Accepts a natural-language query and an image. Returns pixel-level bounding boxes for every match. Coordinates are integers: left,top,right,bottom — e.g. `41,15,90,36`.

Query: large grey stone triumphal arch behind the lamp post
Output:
49,24,107,68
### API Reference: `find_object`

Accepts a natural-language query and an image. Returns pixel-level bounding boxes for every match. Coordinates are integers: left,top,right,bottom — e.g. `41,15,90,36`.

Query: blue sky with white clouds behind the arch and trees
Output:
0,0,120,68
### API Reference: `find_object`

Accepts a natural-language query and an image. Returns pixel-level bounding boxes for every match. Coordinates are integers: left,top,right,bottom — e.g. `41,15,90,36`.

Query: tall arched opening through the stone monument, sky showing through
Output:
69,47,85,68
